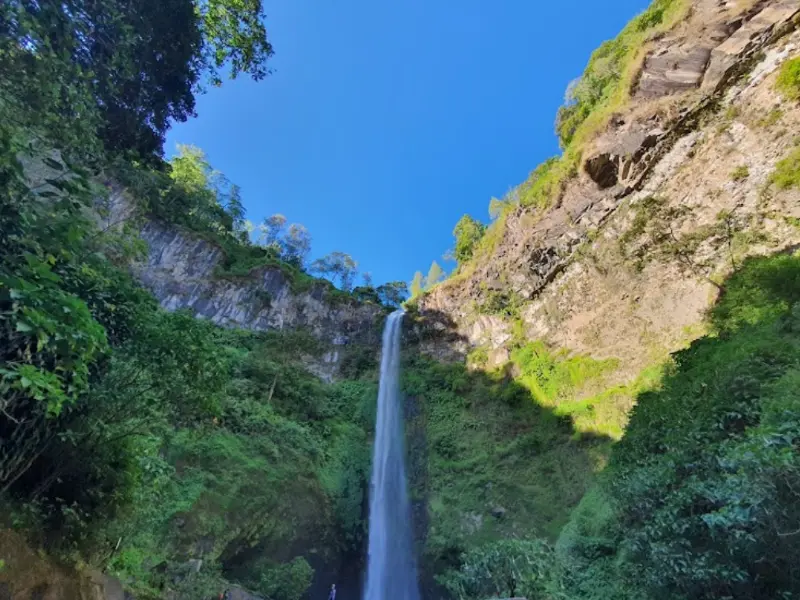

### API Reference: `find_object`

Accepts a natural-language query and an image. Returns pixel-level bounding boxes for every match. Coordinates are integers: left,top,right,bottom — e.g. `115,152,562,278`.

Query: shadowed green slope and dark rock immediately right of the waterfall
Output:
402,310,612,600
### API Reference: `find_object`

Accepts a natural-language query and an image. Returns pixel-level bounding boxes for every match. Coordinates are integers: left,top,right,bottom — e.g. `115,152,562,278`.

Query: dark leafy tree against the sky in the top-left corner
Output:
0,0,272,157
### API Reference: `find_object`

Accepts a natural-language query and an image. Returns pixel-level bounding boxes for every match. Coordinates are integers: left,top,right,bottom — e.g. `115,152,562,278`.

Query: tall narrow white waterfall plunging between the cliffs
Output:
364,311,419,600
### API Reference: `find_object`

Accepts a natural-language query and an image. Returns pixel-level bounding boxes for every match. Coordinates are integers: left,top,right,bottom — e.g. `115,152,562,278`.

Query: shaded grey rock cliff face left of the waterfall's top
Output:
98,188,385,380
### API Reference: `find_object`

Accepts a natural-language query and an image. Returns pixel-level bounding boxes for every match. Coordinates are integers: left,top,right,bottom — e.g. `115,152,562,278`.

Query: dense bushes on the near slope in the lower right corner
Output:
441,254,800,600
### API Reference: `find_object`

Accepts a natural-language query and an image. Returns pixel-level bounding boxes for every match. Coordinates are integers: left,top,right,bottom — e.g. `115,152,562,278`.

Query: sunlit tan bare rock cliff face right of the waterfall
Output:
420,0,800,378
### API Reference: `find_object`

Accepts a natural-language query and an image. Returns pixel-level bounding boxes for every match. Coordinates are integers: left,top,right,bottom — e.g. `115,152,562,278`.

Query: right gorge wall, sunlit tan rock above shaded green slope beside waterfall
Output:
408,0,800,584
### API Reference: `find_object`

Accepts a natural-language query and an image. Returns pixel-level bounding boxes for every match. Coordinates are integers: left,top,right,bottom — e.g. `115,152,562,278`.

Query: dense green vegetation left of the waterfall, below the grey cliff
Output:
0,130,375,598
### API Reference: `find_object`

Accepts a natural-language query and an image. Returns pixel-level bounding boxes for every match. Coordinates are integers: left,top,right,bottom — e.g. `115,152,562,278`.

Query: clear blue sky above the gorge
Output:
167,0,649,283
